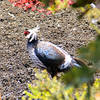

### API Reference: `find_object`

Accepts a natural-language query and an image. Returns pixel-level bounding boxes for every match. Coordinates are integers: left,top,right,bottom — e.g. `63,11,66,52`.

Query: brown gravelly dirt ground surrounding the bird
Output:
0,0,96,100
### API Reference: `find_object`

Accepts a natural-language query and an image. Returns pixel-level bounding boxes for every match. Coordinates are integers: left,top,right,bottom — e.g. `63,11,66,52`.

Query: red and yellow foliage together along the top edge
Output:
8,0,68,12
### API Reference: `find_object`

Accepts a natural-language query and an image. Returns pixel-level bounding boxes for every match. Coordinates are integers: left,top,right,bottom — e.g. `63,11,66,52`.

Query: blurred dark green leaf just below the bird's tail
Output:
62,67,94,86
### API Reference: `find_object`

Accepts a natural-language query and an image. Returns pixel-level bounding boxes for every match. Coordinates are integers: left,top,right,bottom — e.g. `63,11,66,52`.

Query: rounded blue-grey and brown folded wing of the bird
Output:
35,42,65,67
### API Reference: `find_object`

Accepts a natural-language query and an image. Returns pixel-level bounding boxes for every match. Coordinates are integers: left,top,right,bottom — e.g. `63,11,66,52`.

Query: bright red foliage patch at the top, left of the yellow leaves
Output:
8,0,52,15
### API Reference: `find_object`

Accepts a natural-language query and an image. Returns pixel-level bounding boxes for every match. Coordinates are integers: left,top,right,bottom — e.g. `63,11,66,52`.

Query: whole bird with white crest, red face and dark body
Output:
24,27,84,77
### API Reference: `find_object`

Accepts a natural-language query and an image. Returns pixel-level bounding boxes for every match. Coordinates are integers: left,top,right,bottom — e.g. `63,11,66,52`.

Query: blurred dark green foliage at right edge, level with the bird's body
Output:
79,35,100,70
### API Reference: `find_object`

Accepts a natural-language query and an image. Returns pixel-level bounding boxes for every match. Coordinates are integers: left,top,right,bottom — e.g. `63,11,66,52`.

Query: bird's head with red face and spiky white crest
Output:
24,26,39,42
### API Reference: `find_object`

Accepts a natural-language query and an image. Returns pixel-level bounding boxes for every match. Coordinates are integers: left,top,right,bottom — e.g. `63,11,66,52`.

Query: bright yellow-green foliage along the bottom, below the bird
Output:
22,70,100,100
